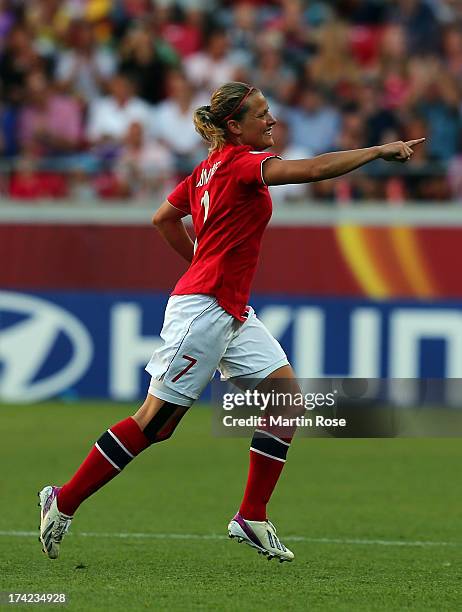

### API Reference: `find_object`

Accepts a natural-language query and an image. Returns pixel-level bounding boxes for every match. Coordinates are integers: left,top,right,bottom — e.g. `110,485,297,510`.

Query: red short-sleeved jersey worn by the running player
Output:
167,144,277,321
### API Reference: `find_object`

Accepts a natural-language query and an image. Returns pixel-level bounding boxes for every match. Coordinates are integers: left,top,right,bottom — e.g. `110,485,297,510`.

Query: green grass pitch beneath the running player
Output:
0,403,462,612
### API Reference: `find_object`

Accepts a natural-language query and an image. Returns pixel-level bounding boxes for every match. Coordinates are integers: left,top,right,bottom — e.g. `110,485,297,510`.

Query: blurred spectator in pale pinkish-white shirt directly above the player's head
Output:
184,28,242,92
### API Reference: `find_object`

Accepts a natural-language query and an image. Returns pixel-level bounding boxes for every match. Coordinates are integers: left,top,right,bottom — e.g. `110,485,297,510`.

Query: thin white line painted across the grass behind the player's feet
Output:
0,531,462,548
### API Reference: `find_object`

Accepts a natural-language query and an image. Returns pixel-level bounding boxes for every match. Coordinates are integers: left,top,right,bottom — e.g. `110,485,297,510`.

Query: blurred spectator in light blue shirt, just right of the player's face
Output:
286,87,340,155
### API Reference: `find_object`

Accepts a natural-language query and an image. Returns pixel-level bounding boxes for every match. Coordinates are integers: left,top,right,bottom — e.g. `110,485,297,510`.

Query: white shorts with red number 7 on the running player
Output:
146,294,289,406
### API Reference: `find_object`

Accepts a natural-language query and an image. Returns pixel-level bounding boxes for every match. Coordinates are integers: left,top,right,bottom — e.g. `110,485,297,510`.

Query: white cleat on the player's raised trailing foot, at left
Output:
38,486,72,559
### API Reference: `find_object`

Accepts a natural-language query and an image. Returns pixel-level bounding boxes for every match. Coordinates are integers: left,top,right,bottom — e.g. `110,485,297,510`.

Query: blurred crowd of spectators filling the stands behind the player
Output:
0,0,462,205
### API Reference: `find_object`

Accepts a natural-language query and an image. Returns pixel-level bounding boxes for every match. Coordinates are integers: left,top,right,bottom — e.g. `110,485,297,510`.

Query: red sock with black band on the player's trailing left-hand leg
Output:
57,417,151,516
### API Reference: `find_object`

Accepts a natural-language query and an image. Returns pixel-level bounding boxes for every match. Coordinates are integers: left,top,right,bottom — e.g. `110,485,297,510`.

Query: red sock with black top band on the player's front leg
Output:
239,430,290,521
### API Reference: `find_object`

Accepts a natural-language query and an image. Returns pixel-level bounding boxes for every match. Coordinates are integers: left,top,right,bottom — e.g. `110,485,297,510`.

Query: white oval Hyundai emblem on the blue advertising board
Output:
0,291,93,402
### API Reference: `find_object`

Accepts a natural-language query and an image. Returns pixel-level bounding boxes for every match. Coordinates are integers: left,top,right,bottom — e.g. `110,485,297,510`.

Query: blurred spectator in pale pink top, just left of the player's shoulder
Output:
115,122,176,200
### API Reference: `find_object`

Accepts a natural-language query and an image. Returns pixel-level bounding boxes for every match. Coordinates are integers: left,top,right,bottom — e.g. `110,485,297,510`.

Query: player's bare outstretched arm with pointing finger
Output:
263,138,425,185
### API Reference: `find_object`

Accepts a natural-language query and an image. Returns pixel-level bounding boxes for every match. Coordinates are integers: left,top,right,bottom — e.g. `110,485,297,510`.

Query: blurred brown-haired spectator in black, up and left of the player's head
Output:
119,22,176,104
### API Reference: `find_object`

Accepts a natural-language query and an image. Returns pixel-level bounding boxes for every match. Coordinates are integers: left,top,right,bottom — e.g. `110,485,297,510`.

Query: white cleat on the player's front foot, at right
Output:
228,512,294,563
